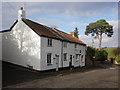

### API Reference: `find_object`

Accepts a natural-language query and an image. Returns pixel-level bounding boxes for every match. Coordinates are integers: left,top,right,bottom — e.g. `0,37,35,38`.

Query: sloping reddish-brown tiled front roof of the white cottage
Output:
23,19,86,45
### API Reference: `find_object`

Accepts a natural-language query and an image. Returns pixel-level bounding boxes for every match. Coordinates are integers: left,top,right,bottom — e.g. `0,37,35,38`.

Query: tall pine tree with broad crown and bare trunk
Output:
85,19,113,50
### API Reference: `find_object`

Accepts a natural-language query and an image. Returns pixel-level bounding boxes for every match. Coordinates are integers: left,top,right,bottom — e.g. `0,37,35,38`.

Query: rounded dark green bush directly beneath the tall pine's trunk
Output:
95,49,108,62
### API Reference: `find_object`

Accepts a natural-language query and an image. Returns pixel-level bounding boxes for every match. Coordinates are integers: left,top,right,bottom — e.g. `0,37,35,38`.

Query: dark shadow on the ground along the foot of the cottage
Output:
2,62,112,87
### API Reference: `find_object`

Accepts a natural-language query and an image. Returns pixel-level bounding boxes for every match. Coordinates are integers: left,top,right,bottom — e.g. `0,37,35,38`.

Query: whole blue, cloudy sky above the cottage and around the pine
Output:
1,2,118,47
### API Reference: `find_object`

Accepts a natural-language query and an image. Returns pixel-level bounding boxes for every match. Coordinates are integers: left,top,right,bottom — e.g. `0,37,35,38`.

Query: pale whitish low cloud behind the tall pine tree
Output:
79,20,118,47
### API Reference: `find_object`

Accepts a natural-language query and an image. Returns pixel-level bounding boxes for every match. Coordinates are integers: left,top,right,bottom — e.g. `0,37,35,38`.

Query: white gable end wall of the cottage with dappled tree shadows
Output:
2,20,41,70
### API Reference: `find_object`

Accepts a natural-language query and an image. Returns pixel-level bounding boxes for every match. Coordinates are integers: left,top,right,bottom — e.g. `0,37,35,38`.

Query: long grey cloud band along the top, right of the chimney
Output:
26,2,117,18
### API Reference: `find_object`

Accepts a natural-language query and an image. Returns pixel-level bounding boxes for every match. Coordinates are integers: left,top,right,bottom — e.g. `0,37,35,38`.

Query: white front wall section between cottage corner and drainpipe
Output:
41,37,62,70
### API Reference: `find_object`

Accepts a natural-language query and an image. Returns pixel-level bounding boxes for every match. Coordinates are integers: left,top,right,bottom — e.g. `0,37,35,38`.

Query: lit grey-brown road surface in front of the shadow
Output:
4,63,119,88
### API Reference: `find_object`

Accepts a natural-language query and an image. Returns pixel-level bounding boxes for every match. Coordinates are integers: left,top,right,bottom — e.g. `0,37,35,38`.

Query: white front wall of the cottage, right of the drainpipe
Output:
63,42,85,67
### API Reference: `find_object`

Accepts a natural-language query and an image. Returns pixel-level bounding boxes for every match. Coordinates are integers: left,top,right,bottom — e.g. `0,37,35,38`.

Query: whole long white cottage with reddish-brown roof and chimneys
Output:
1,8,86,71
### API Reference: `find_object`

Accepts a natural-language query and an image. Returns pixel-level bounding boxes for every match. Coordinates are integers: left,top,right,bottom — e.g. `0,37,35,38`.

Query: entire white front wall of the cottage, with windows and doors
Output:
40,37,85,70
